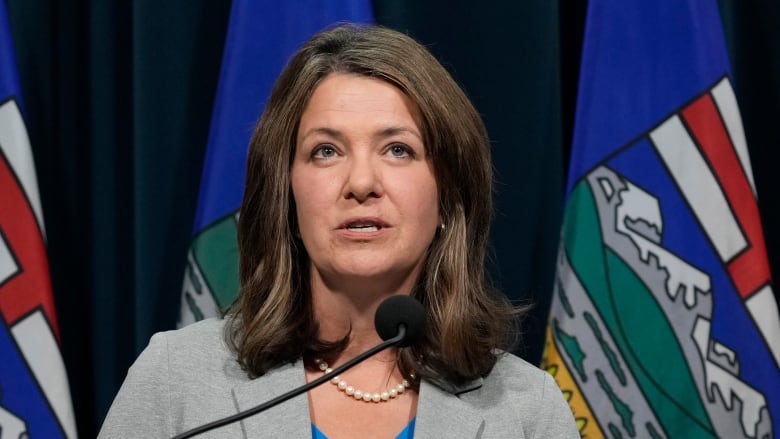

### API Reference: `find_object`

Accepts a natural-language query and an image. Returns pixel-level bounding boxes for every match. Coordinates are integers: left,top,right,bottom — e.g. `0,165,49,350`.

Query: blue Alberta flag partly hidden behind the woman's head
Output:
179,0,374,326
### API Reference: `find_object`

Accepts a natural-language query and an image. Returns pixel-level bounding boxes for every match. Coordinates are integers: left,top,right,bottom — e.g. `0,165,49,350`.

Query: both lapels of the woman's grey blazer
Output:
233,361,484,439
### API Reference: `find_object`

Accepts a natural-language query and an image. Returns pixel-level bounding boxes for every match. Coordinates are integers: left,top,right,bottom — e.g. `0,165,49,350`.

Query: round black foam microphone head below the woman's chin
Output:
374,294,425,346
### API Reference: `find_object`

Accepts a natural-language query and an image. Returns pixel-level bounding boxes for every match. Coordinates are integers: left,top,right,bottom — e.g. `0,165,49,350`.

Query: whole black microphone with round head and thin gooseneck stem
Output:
173,295,425,439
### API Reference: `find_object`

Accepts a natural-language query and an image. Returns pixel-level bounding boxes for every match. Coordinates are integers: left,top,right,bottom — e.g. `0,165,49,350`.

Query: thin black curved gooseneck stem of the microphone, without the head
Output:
173,323,406,439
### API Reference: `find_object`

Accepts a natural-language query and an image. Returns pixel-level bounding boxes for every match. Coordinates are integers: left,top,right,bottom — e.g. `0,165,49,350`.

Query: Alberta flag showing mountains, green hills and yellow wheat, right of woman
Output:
544,0,780,439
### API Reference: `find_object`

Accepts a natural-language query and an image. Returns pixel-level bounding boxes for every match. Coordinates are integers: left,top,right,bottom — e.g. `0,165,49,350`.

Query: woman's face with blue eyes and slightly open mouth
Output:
292,74,441,293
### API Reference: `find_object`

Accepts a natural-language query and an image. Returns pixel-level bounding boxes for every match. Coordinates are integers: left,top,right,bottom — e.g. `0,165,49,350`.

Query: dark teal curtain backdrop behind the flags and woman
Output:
8,0,780,437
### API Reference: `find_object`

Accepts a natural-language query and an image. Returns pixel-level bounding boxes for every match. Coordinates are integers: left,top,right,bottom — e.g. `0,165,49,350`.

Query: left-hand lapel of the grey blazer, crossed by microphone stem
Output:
233,361,311,439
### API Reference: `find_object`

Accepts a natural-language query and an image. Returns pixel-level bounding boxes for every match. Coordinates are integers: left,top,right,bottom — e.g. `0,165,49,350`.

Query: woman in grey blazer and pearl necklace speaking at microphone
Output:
101,25,578,439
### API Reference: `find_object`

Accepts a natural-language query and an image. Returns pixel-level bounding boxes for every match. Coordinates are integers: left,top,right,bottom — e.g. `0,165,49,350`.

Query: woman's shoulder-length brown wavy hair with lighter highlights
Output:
226,24,518,383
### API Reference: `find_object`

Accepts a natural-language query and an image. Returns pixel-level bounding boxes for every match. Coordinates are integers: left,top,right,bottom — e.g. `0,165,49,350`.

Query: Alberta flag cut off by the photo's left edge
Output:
0,0,76,438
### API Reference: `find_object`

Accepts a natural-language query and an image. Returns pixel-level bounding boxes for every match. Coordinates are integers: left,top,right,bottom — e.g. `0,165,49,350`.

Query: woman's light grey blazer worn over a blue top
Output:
98,319,579,439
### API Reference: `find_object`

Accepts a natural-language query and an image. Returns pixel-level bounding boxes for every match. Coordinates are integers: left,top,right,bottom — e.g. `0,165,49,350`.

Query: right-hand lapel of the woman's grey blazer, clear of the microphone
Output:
414,381,485,439
